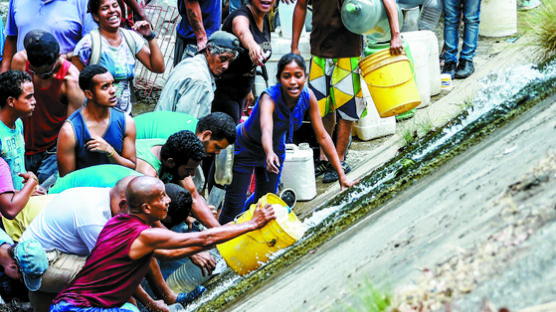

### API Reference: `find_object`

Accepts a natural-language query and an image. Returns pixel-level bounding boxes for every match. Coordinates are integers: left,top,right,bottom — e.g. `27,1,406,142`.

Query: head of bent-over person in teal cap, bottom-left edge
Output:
0,229,48,290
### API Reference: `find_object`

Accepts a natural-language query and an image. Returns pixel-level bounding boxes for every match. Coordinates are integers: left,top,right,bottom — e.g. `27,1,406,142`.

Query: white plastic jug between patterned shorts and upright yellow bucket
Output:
353,83,396,141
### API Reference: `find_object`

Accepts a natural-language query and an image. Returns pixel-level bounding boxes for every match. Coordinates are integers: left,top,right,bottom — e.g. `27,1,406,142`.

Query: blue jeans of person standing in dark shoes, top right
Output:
444,0,481,63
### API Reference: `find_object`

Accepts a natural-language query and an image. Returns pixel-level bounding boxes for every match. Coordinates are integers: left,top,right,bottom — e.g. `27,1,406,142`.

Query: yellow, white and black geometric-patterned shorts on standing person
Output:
309,55,365,120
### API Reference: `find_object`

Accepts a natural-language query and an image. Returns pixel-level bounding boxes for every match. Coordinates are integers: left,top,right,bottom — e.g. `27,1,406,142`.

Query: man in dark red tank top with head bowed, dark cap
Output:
12,29,85,183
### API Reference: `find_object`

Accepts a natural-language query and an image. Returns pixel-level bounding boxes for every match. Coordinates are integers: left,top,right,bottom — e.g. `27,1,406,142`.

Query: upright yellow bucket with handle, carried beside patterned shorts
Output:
359,49,421,117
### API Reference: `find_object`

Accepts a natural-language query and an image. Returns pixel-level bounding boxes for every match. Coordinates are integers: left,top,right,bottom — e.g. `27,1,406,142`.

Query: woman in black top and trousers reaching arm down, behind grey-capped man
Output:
212,0,275,124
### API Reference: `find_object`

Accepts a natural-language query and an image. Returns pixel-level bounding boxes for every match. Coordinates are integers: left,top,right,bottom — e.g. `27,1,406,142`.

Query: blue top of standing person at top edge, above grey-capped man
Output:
177,0,222,39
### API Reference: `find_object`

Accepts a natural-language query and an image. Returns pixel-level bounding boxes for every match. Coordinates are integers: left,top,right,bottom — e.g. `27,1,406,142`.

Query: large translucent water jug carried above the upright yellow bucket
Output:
341,0,403,42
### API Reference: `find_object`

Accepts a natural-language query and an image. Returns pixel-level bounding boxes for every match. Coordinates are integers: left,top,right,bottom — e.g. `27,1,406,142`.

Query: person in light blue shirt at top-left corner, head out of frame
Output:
2,0,97,72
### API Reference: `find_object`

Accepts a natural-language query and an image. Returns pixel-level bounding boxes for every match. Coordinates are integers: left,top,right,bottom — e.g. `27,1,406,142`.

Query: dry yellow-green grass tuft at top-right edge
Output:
524,0,556,63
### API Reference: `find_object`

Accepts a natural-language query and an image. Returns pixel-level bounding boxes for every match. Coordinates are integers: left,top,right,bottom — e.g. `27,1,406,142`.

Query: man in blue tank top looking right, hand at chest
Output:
57,65,136,177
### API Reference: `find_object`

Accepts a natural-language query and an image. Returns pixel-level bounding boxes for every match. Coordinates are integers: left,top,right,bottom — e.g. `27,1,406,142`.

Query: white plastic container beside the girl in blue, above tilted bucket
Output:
281,143,317,201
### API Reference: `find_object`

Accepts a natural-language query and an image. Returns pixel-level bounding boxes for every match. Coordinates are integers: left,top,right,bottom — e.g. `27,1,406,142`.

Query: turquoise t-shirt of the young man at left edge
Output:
0,119,26,191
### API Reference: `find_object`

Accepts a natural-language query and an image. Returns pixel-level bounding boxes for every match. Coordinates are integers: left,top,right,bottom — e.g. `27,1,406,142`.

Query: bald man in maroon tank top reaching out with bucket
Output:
50,176,275,311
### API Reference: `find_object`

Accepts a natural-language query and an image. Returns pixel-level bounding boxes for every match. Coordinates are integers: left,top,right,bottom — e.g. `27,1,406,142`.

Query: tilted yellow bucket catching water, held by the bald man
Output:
216,193,305,275
